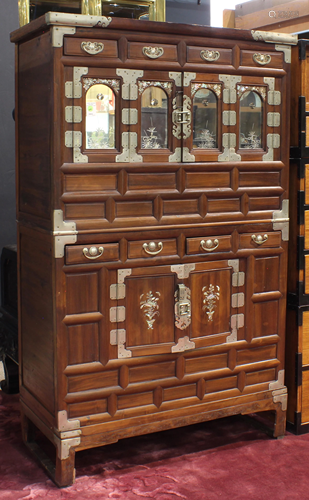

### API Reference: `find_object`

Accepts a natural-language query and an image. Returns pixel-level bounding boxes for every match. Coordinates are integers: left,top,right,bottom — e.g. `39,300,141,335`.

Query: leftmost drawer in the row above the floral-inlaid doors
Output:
65,243,119,264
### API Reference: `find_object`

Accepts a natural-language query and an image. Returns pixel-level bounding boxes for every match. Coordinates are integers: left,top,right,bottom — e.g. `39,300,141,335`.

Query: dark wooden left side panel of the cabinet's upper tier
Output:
17,34,53,219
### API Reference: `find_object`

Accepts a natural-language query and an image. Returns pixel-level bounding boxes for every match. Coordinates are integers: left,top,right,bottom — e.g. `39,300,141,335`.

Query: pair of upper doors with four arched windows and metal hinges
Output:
62,66,283,163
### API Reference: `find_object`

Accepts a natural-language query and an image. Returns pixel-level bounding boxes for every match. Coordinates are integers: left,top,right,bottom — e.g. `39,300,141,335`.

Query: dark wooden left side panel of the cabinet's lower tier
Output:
19,230,55,412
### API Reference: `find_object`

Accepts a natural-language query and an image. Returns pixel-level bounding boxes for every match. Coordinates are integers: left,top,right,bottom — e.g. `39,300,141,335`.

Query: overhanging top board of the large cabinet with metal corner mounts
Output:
11,12,298,45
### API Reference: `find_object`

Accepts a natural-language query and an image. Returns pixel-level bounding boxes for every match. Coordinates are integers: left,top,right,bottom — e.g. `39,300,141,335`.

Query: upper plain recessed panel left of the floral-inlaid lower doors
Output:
66,273,98,314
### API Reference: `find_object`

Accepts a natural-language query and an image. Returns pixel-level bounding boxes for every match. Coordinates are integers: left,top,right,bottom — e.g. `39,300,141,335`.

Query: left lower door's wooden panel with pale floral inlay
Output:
125,275,175,348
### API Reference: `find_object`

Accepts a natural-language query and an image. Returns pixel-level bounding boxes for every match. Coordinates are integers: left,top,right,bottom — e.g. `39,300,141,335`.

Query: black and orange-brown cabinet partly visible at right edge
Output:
286,40,309,434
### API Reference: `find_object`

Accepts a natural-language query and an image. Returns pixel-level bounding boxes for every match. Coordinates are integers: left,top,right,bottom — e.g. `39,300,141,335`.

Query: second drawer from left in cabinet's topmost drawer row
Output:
128,42,178,62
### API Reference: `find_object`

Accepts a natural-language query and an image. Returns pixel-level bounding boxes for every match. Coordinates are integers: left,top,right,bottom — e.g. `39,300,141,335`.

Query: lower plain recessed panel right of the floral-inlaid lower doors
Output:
250,300,279,337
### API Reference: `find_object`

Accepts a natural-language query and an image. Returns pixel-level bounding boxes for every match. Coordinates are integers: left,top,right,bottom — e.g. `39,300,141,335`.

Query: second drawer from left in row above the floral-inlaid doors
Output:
128,238,178,259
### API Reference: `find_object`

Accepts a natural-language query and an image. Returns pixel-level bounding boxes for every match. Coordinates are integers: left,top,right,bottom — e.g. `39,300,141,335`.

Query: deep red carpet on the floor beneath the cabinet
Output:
0,392,309,500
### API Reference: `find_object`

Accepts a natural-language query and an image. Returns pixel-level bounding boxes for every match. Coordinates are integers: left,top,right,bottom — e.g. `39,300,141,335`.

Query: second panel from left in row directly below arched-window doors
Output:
128,172,176,191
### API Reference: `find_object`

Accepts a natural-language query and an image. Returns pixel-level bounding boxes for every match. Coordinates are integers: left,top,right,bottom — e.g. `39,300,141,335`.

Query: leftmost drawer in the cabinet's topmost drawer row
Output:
63,37,118,58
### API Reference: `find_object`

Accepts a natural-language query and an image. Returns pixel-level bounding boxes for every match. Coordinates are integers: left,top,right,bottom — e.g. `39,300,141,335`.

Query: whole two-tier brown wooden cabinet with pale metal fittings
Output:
11,13,296,486
